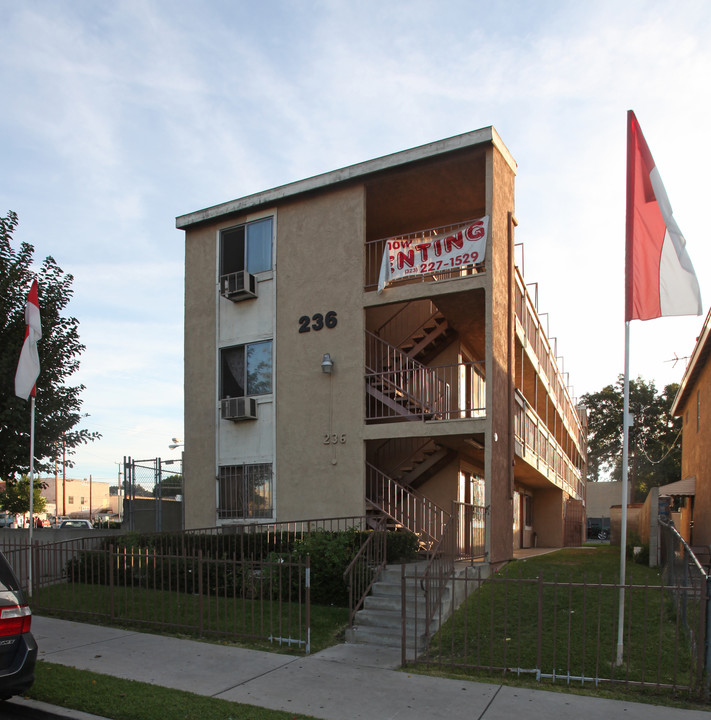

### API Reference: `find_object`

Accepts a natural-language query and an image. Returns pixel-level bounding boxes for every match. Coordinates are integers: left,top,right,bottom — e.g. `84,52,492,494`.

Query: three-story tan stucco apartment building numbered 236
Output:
176,127,585,562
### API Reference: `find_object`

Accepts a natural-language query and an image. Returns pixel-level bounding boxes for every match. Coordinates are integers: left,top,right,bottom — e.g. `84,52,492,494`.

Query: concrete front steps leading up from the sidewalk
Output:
346,561,489,658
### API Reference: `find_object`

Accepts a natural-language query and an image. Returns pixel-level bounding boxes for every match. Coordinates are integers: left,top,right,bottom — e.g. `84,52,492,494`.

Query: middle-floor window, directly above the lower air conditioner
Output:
220,340,272,399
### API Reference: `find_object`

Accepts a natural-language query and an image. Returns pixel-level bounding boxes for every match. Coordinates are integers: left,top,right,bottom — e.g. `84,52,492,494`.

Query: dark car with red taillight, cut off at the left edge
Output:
0,553,37,700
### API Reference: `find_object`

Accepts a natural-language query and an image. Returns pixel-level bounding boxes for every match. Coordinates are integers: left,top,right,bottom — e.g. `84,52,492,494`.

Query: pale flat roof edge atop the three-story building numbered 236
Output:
175,125,516,230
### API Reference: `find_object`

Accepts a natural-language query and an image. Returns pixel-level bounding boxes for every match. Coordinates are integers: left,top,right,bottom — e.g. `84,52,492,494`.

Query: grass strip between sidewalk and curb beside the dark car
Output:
27,661,313,720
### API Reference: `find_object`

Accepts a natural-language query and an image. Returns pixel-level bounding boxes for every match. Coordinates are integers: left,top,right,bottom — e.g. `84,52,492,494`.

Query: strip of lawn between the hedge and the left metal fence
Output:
32,583,348,653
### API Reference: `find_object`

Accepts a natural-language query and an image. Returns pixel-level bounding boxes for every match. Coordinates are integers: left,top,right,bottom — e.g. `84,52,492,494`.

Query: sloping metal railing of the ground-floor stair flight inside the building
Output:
365,463,450,550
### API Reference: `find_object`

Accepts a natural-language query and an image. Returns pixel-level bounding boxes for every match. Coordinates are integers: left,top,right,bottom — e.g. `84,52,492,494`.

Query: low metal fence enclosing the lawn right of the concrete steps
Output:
402,548,709,698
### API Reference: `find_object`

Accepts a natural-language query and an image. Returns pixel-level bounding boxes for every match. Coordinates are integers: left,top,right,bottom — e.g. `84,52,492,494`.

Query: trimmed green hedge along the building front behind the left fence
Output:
67,528,418,607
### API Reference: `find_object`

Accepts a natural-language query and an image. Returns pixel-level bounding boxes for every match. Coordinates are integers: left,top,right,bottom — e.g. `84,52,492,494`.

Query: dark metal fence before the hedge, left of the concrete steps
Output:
2,533,311,653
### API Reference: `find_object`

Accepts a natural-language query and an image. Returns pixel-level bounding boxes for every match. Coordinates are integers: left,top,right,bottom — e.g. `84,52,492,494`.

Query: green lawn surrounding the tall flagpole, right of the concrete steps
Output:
412,546,698,696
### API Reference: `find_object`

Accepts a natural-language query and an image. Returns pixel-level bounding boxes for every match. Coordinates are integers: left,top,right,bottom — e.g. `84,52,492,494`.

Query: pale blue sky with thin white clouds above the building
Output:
0,0,711,480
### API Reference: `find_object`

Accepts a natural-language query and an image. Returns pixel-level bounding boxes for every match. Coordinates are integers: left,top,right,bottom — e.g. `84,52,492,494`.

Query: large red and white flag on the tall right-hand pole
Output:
625,110,702,320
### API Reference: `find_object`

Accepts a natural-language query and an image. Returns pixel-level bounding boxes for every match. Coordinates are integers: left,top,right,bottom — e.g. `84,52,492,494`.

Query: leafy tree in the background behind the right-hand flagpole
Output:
581,375,681,502
